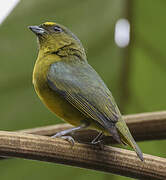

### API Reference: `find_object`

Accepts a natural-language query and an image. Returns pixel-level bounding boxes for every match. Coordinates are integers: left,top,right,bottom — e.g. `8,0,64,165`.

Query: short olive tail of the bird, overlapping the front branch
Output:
115,118,143,161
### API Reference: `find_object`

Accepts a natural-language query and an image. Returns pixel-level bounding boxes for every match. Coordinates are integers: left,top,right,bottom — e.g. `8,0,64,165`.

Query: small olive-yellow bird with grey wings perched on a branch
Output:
29,22,143,161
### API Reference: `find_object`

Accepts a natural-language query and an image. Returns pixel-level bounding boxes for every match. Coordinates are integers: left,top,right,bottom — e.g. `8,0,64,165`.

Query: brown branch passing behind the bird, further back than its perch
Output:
19,111,166,144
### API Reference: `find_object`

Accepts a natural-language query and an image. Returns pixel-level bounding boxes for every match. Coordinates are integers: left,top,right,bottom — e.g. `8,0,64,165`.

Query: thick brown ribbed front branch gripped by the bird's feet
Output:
0,131,166,179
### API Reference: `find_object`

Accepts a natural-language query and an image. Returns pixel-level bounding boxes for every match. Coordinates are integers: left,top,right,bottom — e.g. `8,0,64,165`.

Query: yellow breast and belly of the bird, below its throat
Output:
33,54,85,126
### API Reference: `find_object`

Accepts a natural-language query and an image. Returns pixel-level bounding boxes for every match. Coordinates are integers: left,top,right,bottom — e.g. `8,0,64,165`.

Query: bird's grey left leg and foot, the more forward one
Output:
51,123,89,145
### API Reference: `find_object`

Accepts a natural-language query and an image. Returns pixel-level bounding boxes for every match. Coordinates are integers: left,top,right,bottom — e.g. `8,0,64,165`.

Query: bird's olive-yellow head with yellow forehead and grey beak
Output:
29,22,86,59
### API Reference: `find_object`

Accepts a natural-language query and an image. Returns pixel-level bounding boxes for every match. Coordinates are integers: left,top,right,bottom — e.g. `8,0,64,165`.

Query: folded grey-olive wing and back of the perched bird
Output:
47,62,120,134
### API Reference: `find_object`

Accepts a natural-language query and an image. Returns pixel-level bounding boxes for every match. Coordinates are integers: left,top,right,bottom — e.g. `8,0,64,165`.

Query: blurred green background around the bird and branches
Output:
0,0,166,180
